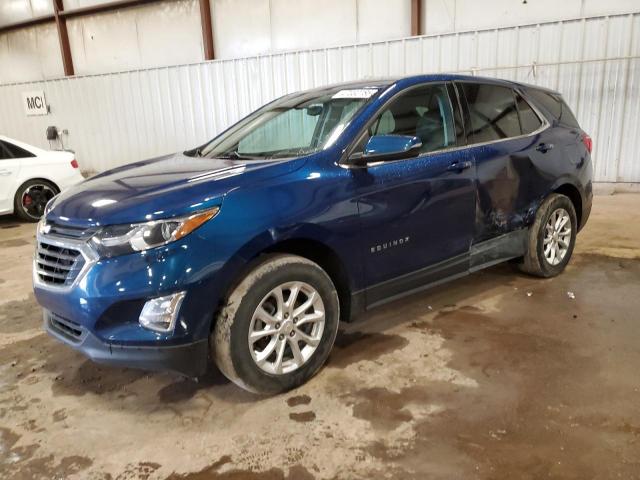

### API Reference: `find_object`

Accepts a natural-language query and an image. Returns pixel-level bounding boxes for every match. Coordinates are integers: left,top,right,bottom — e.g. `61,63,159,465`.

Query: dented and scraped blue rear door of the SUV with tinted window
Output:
456,81,555,243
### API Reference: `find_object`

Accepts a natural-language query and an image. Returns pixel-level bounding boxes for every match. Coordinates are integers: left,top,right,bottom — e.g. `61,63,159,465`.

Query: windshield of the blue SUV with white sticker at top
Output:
187,88,378,159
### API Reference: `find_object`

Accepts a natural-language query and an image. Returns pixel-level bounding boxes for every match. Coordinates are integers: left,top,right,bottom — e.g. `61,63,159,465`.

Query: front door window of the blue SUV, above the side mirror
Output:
358,84,456,153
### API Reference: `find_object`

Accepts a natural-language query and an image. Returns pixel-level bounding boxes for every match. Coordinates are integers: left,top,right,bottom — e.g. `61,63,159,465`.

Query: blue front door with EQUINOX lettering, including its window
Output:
352,83,475,305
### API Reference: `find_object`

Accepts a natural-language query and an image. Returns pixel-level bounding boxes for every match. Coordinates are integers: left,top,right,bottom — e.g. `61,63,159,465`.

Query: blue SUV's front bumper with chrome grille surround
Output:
33,219,232,377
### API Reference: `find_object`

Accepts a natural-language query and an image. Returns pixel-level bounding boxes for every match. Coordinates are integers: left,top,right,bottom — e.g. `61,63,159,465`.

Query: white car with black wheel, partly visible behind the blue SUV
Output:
0,135,83,222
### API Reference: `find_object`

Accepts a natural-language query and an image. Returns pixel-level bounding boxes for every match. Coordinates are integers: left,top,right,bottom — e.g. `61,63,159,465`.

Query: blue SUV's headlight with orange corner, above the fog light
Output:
91,207,220,257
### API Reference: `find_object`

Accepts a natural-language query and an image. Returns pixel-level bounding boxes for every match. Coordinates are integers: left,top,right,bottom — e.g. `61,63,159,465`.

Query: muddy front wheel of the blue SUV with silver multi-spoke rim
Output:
210,254,340,395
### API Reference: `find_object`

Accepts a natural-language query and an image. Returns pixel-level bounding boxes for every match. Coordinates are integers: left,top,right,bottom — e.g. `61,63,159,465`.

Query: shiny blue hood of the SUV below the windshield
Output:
46,153,304,228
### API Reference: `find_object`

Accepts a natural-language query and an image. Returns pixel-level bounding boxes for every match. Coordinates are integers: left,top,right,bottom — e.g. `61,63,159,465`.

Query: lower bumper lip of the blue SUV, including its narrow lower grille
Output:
44,310,209,377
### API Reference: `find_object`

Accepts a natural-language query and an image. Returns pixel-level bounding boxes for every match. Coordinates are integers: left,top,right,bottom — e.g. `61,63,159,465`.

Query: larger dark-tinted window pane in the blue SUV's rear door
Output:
460,82,521,143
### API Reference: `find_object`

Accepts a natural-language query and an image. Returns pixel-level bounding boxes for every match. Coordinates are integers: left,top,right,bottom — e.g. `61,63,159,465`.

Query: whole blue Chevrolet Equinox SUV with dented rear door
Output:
33,75,592,394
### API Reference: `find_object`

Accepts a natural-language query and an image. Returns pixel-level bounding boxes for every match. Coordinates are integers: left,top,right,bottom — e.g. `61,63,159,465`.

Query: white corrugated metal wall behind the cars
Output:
0,13,640,182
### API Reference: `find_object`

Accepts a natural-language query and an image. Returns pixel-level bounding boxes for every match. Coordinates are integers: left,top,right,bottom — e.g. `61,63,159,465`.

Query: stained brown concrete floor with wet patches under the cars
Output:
0,194,640,480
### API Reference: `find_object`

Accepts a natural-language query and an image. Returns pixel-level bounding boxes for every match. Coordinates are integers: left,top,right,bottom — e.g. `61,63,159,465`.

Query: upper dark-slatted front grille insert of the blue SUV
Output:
36,241,85,286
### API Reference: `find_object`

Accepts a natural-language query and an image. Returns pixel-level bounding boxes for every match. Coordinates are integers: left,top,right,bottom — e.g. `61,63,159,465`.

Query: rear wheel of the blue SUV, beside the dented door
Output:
519,193,578,278
